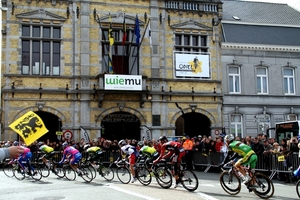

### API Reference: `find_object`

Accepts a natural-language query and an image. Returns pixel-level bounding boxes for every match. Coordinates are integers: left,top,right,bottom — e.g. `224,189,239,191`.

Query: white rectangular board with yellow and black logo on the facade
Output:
174,52,210,78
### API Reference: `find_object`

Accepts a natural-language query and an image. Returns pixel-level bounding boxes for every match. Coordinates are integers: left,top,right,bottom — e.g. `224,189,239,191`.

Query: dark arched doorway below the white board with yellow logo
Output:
175,112,211,137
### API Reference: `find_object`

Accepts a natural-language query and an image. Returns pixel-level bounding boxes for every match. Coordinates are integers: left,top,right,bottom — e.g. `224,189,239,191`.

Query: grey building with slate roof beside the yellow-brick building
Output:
222,1,300,137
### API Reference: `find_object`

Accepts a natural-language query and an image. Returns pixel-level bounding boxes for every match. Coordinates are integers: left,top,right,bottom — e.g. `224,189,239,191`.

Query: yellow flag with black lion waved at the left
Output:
9,111,48,146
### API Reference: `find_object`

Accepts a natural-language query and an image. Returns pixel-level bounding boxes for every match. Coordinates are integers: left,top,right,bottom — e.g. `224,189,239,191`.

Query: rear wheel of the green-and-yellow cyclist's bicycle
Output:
252,172,274,199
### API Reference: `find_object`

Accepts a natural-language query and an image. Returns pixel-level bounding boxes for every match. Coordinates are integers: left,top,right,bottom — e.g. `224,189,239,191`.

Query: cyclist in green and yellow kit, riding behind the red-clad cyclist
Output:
221,134,257,184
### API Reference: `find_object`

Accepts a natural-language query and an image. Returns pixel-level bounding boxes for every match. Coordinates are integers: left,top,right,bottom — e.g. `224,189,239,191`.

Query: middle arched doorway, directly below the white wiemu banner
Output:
101,111,141,140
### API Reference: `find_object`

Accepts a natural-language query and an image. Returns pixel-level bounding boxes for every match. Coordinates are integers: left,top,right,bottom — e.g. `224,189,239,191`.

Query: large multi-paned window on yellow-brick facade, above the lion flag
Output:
21,25,61,76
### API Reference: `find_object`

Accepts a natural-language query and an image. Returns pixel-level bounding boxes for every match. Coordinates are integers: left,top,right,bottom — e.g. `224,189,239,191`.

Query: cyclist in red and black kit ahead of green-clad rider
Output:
153,136,185,188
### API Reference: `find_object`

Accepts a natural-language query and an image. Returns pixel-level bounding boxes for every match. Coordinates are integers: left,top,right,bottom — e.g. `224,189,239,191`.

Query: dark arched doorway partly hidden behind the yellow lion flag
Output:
35,111,62,142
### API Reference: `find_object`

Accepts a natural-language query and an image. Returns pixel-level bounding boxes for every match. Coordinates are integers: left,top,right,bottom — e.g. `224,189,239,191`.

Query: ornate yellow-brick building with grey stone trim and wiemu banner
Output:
0,0,224,141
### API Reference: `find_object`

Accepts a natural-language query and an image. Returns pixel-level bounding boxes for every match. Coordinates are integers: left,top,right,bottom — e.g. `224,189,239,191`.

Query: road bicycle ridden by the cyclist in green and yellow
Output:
220,161,274,199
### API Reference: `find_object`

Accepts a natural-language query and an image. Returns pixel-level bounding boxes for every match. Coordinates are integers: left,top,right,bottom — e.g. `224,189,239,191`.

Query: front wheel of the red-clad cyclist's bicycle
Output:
154,167,173,189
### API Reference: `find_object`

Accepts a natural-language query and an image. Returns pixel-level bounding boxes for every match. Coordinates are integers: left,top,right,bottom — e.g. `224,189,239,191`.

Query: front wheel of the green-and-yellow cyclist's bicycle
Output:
220,171,241,195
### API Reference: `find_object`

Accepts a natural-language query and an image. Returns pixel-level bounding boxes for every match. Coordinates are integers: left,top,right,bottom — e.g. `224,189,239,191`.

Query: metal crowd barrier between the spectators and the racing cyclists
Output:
7,151,300,179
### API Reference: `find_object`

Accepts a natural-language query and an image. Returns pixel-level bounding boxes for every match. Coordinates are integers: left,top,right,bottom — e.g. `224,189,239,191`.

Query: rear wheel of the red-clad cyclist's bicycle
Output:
180,169,199,192
